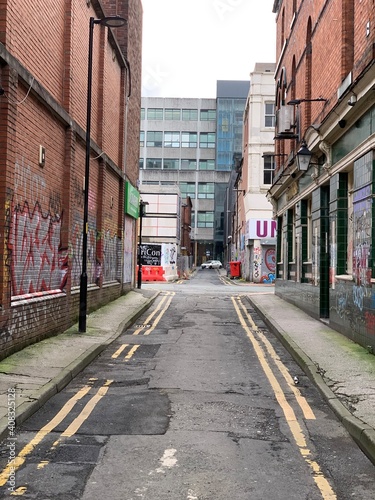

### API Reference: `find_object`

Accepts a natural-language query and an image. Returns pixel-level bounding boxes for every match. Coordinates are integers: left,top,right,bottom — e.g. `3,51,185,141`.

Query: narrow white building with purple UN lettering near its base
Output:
239,63,276,283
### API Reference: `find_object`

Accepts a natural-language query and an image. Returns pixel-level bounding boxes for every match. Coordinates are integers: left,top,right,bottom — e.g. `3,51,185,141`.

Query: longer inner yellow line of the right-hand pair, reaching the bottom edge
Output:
231,297,337,500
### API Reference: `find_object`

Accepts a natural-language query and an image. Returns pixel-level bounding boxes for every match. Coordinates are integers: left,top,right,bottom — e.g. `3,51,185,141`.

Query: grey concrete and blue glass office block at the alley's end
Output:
139,81,250,265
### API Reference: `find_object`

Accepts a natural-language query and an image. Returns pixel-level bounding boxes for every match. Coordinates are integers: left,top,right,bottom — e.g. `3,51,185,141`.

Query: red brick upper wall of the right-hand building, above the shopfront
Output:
276,0,375,143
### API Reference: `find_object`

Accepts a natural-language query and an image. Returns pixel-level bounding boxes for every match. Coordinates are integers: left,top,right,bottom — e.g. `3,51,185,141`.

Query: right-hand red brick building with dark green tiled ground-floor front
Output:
268,0,375,349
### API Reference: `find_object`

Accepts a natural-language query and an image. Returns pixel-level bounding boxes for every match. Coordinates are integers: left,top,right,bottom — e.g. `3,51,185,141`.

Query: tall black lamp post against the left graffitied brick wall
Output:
78,16,126,333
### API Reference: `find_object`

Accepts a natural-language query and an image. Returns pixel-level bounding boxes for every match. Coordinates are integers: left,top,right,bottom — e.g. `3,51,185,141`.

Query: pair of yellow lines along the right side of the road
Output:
231,297,337,500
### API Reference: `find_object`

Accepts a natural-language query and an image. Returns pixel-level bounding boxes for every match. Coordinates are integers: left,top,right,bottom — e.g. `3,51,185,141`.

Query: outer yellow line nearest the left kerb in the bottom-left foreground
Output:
0,385,91,486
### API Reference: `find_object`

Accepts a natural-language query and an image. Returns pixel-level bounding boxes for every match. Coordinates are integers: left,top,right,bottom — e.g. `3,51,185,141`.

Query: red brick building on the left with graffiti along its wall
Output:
0,0,142,357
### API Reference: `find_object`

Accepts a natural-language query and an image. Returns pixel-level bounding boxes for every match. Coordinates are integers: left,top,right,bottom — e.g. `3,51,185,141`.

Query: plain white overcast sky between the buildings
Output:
142,0,276,98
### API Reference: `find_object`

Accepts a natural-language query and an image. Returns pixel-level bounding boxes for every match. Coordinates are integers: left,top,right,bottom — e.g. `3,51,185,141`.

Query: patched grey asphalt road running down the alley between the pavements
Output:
0,270,375,500
